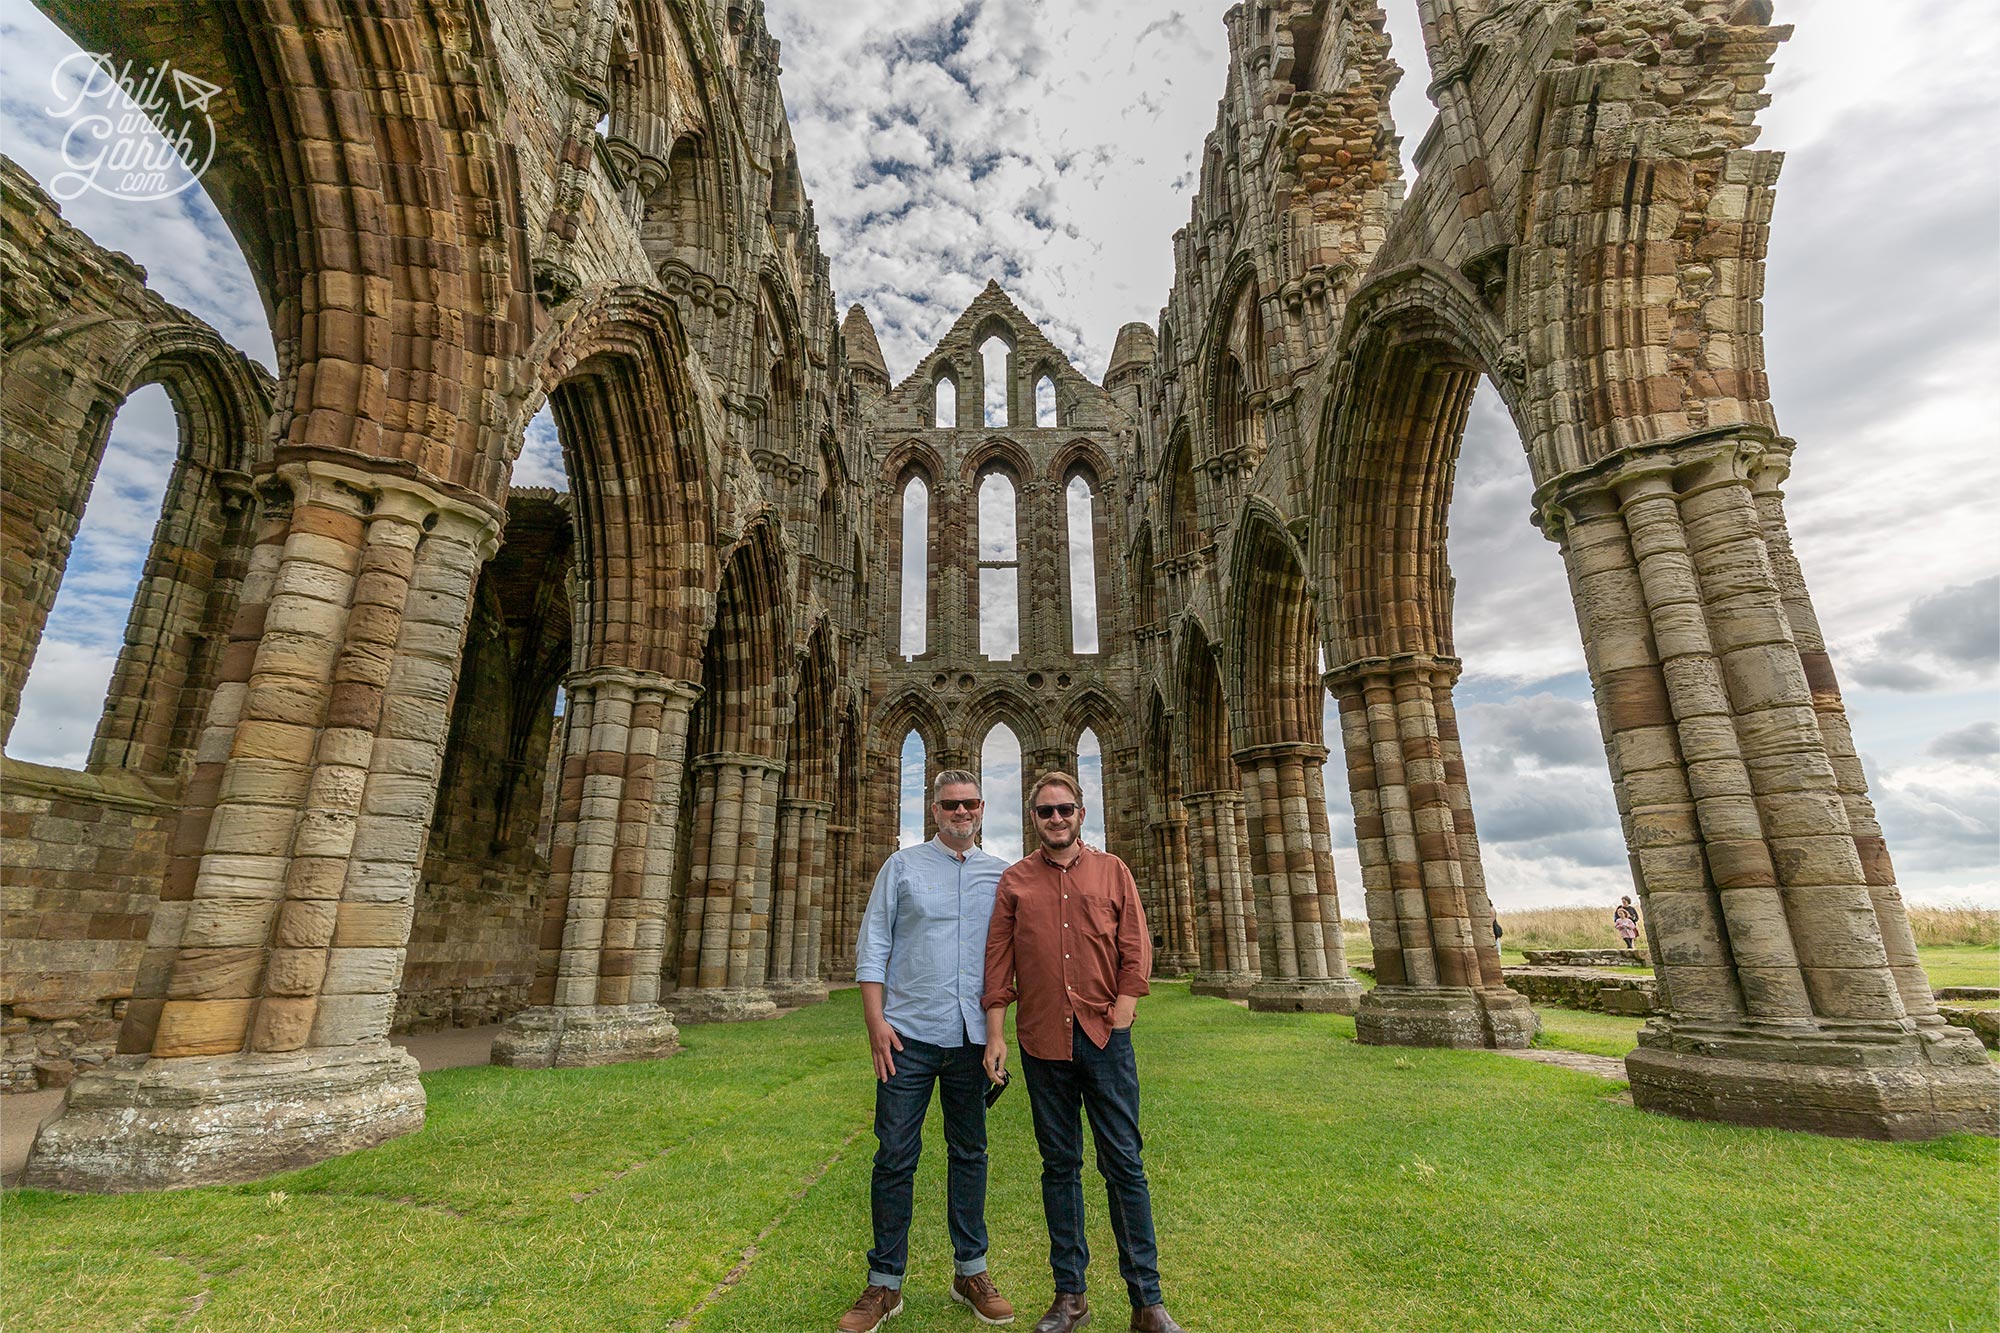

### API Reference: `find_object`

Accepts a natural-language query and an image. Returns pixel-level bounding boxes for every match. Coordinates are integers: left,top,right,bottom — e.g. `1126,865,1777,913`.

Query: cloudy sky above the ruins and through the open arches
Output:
0,0,2000,911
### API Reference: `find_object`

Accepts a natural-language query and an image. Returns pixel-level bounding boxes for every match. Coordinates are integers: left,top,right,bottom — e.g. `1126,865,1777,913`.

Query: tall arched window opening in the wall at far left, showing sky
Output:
6,384,180,769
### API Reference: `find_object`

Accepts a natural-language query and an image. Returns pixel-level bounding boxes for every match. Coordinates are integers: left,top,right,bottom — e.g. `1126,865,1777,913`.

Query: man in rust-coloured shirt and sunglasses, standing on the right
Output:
982,773,1182,1333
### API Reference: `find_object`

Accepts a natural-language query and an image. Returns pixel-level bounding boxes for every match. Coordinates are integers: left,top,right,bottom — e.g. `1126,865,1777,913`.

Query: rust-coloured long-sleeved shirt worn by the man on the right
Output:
982,847,1152,1061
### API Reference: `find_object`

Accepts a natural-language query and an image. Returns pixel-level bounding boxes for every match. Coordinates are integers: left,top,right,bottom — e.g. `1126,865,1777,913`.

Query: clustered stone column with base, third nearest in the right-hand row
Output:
1236,743,1362,1013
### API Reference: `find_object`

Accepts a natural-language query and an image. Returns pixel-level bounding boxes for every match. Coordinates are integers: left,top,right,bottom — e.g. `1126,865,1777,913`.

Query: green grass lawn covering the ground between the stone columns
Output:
0,985,2000,1333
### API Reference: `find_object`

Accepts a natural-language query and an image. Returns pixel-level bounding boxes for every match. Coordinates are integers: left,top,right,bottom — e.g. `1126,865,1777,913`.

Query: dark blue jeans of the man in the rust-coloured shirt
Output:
1020,1029,1160,1309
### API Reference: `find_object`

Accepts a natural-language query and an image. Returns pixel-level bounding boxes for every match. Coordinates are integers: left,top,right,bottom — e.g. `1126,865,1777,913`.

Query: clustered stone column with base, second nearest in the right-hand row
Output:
1326,654,1534,1047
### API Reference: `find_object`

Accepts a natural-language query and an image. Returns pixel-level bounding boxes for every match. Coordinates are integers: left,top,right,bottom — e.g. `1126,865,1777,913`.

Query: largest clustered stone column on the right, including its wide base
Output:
1536,430,2000,1139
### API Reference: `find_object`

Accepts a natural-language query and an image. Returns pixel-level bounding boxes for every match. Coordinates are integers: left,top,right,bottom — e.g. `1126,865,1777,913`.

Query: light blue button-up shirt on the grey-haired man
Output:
854,839,1006,1047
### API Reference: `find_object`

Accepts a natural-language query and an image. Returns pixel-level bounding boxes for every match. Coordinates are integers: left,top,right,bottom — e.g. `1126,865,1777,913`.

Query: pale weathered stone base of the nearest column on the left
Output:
22,1041,424,1195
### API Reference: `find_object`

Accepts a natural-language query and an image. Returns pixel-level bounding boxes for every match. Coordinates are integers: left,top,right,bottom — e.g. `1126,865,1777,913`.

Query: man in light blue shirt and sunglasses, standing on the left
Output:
840,769,1014,1333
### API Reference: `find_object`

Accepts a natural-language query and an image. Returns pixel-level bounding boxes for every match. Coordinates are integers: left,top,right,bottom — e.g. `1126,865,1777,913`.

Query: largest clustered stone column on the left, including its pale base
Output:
24,462,500,1191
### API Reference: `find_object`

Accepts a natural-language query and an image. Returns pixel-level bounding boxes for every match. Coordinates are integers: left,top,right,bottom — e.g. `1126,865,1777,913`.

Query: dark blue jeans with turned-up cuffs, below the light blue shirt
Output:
868,1033,986,1287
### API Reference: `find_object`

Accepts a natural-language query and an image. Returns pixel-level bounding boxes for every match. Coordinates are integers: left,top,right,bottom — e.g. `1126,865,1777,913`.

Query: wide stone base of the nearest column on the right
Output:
1626,1017,2000,1141
